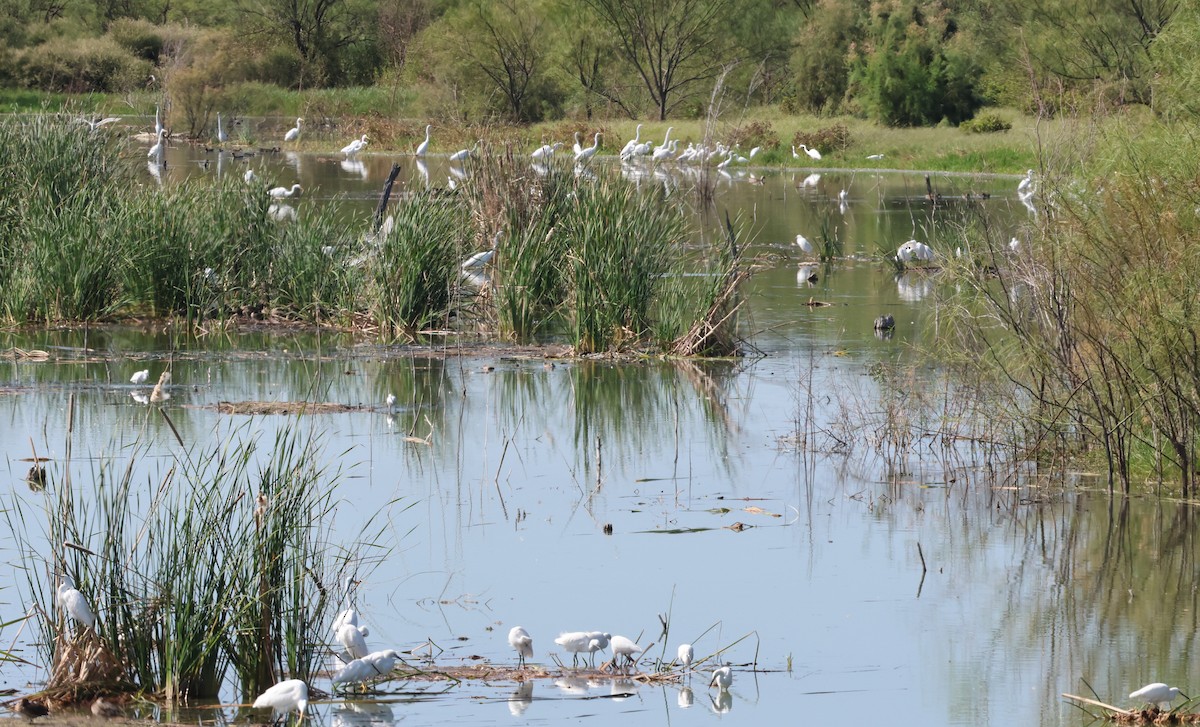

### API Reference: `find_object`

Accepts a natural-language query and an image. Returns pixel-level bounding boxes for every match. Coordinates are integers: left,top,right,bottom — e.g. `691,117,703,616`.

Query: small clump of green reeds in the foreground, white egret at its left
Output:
6,422,386,703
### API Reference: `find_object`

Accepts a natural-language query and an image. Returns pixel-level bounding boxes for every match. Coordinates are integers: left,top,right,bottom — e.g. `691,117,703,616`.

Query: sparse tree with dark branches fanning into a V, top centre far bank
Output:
583,0,738,120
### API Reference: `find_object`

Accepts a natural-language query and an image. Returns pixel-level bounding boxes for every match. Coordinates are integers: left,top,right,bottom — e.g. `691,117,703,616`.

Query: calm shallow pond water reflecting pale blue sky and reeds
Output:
0,148,1200,725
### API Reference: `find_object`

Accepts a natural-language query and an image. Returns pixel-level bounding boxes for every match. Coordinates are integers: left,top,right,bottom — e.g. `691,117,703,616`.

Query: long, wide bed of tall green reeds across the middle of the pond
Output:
0,115,742,355
